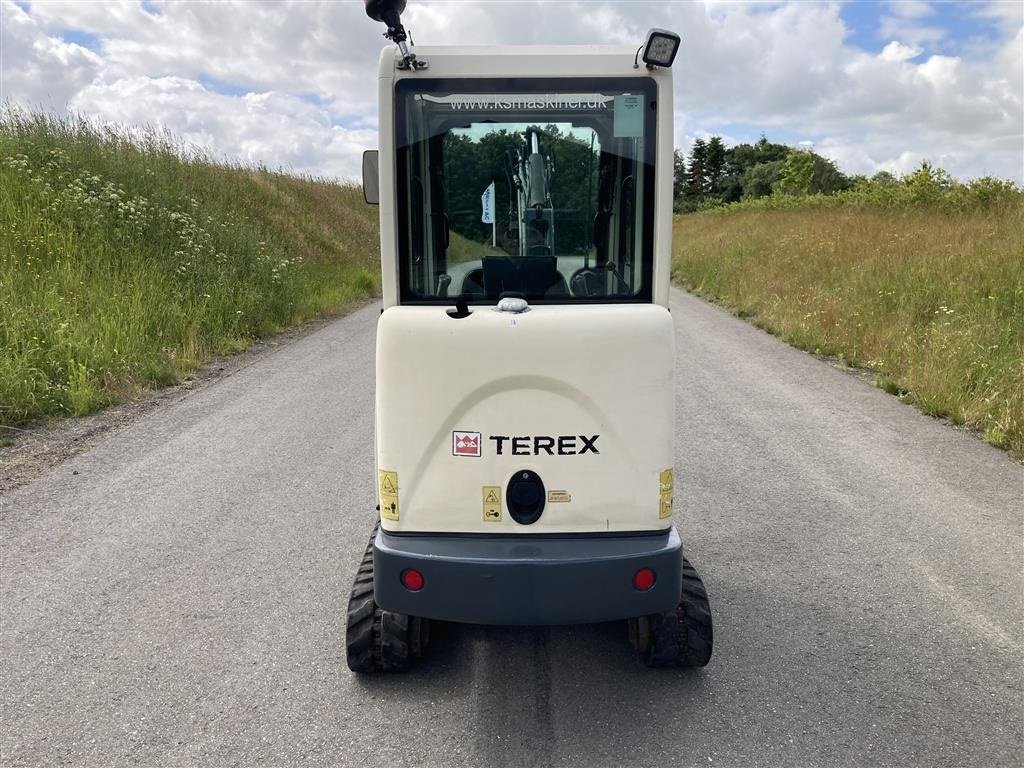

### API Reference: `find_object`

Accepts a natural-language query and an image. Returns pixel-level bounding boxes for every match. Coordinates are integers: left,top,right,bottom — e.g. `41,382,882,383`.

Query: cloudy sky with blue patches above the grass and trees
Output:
6,0,1024,183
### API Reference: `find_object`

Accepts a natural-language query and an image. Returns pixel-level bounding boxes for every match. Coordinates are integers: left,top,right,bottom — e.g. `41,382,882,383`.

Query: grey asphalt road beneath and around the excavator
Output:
0,293,1024,768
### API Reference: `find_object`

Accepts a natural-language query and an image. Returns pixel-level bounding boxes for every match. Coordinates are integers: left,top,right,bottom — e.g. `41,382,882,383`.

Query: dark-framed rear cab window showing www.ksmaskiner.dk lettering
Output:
396,78,655,304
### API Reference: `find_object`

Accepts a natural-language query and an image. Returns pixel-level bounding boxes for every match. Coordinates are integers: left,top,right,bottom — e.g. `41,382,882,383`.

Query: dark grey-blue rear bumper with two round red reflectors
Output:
374,528,682,625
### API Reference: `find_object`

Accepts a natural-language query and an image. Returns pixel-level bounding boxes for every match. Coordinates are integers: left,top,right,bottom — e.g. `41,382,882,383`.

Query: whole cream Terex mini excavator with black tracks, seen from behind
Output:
347,0,712,672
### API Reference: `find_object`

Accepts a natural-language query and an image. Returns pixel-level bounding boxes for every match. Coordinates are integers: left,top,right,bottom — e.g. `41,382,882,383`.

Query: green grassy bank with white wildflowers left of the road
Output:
0,110,380,433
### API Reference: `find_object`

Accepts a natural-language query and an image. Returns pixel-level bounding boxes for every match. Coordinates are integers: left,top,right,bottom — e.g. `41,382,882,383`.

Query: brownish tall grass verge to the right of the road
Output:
673,201,1024,460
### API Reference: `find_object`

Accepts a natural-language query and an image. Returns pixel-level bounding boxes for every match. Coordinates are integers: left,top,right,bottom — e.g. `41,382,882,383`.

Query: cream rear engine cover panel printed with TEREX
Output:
376,303,674,535
